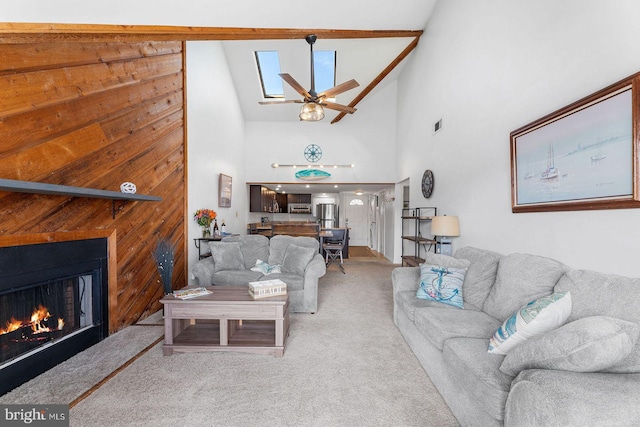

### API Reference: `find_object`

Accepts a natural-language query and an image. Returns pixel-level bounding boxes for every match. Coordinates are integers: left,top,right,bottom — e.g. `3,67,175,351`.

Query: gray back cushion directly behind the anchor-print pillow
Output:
454,246,502,309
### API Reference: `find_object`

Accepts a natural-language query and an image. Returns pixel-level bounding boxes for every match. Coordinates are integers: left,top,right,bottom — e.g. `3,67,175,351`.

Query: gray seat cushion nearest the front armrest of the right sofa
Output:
442,338,513,420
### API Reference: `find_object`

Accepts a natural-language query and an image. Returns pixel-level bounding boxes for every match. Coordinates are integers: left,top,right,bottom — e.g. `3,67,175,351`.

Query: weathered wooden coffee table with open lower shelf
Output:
160,286,289,357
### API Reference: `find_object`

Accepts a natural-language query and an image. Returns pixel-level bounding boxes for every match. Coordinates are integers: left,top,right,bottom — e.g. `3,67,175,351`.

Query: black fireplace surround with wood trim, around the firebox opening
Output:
0,230,117,395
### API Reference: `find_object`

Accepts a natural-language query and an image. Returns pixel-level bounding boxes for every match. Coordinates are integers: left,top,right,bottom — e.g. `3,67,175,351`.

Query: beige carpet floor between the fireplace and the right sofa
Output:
0,259,458,427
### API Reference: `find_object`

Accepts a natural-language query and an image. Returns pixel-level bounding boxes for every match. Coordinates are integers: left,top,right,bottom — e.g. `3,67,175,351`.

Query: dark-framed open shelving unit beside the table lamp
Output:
401,206,438,267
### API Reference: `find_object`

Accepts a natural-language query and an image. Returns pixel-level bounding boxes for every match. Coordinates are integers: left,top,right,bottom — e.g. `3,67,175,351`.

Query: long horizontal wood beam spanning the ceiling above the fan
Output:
0,22,422,43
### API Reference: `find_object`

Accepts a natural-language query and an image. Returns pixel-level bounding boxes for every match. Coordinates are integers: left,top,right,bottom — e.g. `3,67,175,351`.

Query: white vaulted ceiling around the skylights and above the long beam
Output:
1,0,437,121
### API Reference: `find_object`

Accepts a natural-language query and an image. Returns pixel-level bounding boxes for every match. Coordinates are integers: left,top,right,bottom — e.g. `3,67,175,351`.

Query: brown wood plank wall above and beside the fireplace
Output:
0,40,187,332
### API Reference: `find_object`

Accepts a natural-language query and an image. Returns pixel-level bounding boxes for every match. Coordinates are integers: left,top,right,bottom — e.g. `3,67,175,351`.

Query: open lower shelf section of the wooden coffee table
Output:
162,319,289,357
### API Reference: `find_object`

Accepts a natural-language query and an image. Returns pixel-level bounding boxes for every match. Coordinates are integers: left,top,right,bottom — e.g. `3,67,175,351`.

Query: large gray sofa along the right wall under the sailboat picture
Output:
392,247,640,427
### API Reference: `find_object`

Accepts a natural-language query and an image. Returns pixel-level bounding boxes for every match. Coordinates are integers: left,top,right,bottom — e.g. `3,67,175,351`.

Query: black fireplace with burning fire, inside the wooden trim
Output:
0,239,108,395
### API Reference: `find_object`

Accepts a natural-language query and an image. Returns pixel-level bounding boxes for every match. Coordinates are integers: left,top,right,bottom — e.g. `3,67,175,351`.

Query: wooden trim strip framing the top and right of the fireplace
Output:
0,229,118,334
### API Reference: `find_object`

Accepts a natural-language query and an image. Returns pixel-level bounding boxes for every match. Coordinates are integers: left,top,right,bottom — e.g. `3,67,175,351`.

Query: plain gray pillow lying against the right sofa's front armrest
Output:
500,316,640,376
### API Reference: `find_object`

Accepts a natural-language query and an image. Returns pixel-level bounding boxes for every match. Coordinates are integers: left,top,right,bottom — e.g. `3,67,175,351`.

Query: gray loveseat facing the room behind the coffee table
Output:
191,234,327,313
